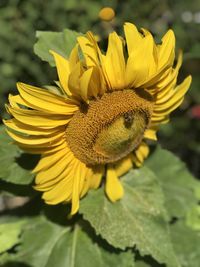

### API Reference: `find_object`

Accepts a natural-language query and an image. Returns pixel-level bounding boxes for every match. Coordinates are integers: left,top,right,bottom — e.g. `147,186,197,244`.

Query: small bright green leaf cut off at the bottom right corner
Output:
171,220,200,267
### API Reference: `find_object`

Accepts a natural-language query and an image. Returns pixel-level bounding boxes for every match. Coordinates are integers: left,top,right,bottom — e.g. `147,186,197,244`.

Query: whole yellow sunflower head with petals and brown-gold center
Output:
4,23,191,214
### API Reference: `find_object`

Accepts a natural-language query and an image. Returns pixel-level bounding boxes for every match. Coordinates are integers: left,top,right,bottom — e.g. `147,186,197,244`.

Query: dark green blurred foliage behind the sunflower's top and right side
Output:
0,0,200,176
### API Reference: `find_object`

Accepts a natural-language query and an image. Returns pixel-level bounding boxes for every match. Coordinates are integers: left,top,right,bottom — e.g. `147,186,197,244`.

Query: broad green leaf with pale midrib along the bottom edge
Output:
10,217,134,267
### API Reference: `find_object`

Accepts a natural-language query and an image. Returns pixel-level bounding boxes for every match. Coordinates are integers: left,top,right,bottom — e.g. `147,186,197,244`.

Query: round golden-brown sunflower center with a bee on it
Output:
66,89,153,165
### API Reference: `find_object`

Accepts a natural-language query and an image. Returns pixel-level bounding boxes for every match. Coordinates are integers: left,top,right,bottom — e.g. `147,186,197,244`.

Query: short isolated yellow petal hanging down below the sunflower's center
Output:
105,166,124,202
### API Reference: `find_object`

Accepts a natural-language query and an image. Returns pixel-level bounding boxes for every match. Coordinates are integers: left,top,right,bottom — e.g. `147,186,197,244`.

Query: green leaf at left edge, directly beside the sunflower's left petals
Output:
0,126,36,184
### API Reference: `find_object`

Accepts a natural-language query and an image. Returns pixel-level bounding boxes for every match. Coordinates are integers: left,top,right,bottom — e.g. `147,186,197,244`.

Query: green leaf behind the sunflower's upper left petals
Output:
34,29,82,66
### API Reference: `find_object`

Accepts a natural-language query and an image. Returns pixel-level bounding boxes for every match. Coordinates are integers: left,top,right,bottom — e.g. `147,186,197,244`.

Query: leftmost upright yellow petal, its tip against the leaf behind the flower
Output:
49,50,71,95
